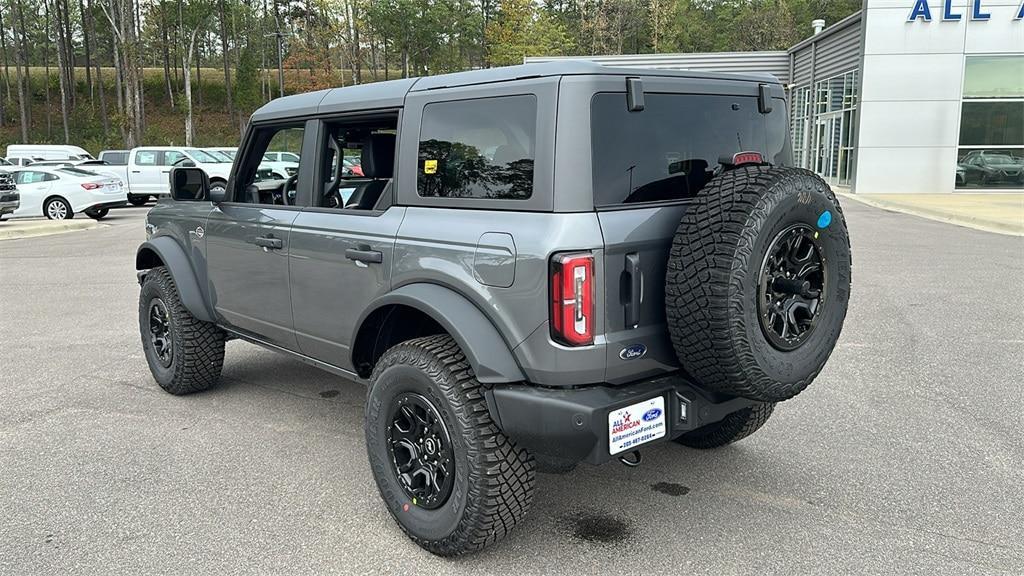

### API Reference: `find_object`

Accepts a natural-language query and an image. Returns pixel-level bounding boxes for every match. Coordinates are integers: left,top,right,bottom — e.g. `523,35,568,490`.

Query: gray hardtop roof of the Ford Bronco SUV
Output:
252,59,778,122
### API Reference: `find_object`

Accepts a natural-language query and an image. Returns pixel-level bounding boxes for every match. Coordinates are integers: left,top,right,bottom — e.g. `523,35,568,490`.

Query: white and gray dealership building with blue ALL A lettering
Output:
527,0,1024,194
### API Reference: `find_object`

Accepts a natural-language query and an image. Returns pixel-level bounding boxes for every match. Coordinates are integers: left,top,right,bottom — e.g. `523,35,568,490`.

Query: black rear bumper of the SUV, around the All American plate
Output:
486,375,760,464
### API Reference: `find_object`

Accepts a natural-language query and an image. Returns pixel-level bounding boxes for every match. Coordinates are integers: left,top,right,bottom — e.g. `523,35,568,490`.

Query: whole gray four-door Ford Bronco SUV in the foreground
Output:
135,61,850,556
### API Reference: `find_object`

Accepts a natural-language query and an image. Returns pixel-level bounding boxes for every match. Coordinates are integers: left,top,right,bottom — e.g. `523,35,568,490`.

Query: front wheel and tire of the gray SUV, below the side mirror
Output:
138,266,224,395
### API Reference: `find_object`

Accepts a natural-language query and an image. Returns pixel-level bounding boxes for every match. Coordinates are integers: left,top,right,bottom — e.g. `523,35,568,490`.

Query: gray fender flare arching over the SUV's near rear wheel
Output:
349,283,526,384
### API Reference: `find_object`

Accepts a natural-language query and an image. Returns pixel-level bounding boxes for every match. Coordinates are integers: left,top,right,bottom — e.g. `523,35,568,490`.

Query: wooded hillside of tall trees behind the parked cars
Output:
0,0,860,152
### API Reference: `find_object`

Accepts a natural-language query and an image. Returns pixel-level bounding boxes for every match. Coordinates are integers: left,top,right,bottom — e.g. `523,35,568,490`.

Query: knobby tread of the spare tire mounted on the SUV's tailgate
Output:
665,166,849,402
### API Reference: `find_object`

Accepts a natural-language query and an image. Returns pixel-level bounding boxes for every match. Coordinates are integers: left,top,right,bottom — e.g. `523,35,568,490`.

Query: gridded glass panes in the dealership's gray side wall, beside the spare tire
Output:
807,70,858,186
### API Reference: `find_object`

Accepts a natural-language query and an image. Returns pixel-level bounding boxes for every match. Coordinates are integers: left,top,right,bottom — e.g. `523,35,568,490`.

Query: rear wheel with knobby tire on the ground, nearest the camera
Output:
366,335,536,557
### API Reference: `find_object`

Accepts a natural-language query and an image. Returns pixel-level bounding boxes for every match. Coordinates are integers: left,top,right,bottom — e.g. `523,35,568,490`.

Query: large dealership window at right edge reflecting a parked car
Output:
955,55,1024,190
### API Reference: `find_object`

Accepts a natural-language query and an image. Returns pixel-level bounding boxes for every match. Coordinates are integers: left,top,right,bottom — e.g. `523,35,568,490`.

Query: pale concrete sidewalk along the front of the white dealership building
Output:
839,192,1024,236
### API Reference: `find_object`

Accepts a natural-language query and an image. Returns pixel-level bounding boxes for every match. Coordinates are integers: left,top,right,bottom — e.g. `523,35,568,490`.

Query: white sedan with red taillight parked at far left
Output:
12,166,128,220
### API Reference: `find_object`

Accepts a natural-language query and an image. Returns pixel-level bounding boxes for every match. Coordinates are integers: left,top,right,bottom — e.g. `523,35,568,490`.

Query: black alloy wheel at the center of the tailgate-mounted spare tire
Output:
758,223,827,352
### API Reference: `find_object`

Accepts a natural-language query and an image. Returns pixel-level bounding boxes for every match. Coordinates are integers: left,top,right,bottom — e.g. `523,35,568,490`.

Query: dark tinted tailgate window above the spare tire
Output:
591,92,791,206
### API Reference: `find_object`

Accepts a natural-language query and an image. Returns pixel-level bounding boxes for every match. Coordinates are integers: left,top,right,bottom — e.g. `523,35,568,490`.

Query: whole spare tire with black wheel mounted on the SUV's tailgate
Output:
666,166,850,402
